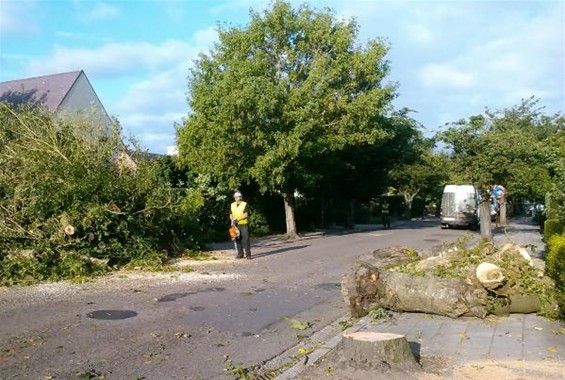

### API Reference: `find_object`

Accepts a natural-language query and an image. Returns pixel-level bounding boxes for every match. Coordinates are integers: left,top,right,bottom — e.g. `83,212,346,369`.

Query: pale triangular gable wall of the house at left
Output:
58,72,112,126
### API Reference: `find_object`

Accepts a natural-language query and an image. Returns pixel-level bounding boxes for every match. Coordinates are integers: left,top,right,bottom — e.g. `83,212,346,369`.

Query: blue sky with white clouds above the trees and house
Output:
0,0,565,153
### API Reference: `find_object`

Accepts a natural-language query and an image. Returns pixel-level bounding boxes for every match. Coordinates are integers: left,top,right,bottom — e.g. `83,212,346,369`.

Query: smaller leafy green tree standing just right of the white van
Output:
439,97,557,238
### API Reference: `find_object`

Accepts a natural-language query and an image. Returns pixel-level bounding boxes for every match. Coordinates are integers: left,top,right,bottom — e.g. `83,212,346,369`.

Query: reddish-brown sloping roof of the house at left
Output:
0,70,83,111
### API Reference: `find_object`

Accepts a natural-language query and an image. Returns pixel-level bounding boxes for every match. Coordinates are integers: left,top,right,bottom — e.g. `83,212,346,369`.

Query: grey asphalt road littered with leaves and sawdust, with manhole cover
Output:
0,219,468,380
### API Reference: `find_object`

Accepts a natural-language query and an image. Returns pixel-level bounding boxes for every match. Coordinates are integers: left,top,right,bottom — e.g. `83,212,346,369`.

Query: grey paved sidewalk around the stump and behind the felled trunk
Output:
277,218,565,380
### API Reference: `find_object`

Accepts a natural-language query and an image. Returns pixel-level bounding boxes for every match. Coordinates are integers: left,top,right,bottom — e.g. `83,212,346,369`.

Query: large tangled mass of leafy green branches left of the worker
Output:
0,103,203,284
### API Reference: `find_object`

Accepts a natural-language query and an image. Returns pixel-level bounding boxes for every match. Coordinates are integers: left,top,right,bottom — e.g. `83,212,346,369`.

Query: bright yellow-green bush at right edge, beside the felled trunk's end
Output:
546,234,565,319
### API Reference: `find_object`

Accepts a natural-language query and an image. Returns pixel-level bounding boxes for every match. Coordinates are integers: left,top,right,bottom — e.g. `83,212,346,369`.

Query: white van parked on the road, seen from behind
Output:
440,185,479,229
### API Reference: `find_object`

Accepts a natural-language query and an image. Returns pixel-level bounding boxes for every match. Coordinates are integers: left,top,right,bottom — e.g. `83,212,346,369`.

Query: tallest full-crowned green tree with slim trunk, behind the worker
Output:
178,1,395,236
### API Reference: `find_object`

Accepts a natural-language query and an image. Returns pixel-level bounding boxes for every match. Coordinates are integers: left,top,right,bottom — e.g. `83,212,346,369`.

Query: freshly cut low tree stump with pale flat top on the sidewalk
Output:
341,331,419,370
